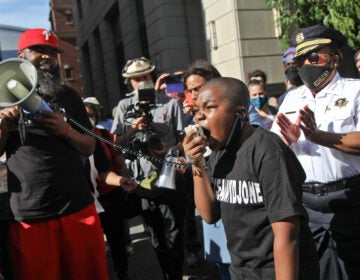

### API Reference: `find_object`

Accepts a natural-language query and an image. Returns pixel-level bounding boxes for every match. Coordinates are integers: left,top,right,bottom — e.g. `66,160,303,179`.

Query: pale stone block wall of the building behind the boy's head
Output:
202,0,284,93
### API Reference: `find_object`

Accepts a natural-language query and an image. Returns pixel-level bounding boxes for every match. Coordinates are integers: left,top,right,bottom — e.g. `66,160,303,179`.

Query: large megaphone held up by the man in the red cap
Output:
0,58,53,113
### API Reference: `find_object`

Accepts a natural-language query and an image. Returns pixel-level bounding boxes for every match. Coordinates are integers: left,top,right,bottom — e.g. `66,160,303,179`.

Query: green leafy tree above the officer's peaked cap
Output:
265,0,360,50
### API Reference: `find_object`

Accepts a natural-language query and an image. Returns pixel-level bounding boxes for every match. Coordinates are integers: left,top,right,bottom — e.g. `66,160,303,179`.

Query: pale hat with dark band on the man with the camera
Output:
121,57,155,78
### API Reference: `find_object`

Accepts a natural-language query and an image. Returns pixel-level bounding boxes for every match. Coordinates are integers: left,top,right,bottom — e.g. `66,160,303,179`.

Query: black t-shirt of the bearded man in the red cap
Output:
6,87,94,221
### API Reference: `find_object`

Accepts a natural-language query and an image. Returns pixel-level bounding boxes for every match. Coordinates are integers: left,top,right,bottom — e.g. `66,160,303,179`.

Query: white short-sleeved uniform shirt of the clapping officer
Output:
271,73,360,183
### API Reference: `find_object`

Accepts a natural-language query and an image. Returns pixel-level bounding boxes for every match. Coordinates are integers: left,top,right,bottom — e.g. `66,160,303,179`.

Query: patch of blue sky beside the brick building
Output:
0,0,50,30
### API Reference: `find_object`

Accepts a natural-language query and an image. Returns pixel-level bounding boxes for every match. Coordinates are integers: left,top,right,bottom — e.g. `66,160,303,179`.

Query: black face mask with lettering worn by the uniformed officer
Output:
299,64,333,90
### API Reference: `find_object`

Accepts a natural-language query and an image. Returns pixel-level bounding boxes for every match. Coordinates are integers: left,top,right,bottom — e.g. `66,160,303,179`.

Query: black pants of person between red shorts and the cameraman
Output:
99,188,128,279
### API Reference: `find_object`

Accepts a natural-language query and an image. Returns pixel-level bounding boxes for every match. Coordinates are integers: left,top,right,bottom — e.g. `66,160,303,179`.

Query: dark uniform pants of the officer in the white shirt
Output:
303,185,360,280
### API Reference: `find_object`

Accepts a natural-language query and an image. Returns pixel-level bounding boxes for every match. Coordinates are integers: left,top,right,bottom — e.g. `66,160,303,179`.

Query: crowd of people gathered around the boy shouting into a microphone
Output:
0,25,360,280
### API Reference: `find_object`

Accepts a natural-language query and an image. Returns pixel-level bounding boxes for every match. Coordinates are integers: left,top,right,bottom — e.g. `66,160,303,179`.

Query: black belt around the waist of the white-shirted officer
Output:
302,175,360,196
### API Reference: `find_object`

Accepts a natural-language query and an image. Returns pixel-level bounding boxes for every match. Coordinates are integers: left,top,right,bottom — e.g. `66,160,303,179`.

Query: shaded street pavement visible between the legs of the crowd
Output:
108,216,221,280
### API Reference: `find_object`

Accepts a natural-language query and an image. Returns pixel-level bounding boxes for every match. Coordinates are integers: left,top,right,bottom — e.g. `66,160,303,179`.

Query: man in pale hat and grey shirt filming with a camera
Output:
111,57,184,280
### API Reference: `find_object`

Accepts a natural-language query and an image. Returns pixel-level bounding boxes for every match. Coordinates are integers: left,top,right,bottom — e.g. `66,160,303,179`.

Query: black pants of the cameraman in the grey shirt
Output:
126,189,184,280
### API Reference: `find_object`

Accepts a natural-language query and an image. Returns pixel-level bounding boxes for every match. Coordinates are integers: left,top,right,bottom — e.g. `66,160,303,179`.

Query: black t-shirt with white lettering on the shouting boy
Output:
208,118,317,280
